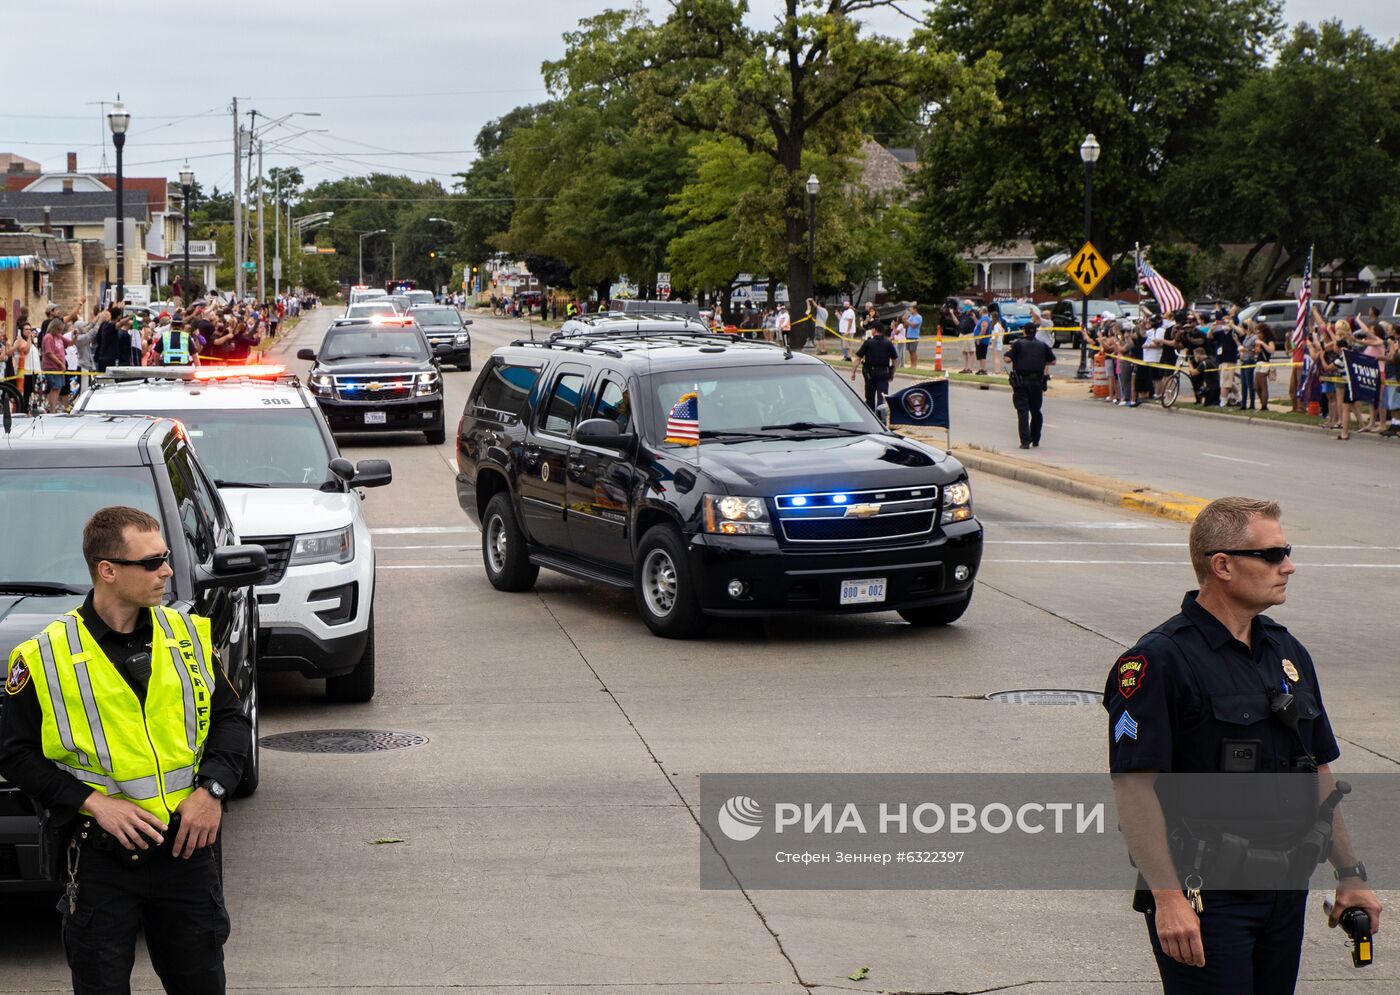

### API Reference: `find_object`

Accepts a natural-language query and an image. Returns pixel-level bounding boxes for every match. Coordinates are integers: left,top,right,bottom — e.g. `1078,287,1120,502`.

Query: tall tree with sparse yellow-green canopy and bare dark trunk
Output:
545,0,937,314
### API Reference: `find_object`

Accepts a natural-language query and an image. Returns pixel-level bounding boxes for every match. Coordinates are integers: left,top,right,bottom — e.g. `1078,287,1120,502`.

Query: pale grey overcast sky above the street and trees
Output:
0,0,1400,189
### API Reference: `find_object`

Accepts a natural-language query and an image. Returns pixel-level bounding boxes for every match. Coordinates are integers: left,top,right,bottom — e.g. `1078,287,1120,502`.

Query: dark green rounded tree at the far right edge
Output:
1169,21,1400,298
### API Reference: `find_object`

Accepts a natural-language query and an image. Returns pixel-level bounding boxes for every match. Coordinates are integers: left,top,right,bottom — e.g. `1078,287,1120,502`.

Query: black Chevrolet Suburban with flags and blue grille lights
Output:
456,332,983,638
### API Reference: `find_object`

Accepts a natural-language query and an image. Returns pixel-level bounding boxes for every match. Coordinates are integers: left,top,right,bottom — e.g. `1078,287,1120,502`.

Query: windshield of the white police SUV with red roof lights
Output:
161,406,336,488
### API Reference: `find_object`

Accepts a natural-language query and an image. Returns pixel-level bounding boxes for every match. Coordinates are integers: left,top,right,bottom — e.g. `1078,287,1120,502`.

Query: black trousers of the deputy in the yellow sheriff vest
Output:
59,819,230,995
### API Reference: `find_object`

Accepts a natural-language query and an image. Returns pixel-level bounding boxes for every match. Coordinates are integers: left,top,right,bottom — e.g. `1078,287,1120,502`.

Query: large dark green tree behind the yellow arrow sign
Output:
917,0,1278,268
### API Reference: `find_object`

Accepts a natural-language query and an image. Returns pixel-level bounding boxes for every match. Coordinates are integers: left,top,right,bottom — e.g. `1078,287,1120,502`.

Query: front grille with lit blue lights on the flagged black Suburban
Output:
774,484,938,543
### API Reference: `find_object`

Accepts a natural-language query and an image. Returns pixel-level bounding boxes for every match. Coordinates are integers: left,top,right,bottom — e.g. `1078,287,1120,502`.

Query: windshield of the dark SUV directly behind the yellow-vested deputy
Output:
0,467,165,593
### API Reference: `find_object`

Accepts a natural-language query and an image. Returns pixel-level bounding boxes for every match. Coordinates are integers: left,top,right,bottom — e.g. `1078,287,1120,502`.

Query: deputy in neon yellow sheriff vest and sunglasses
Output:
0,507,252,995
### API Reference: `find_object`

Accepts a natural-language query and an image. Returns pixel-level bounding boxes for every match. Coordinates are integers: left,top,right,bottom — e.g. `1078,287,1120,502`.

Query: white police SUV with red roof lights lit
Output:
74,367,392,701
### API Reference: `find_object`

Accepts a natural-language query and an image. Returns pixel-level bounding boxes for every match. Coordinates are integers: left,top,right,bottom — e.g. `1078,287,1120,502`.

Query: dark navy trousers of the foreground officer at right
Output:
1147,890,1308,995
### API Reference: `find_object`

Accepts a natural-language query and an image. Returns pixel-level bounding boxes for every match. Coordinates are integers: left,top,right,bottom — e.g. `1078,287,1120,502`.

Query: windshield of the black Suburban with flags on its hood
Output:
650,365,885,444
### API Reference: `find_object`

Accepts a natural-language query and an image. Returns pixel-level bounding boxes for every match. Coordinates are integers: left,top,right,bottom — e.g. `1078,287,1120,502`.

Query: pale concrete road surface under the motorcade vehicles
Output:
0,311,1400,995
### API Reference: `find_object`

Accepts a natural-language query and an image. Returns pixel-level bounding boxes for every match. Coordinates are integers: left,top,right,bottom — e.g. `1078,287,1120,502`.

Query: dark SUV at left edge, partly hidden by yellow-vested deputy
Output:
0,414,267,894
